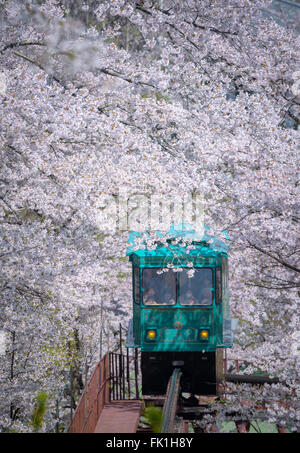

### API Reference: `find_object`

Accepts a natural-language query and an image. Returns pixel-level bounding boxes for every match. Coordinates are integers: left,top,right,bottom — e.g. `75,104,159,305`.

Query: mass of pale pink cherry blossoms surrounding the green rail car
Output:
0,0,300,431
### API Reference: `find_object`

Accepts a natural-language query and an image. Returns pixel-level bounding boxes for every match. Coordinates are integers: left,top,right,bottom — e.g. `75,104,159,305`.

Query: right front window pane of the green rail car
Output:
179,268,213,305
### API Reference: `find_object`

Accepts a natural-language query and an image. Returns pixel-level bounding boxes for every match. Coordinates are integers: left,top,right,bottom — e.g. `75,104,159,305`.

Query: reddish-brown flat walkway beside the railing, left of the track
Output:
94,400,143,433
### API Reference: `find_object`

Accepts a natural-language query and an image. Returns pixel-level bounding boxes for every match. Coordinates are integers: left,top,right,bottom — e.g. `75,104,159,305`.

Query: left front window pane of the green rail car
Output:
143,268,176,305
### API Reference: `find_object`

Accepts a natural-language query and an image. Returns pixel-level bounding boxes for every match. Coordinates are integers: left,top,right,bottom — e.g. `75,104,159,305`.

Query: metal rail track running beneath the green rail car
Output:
161,368,182,433
